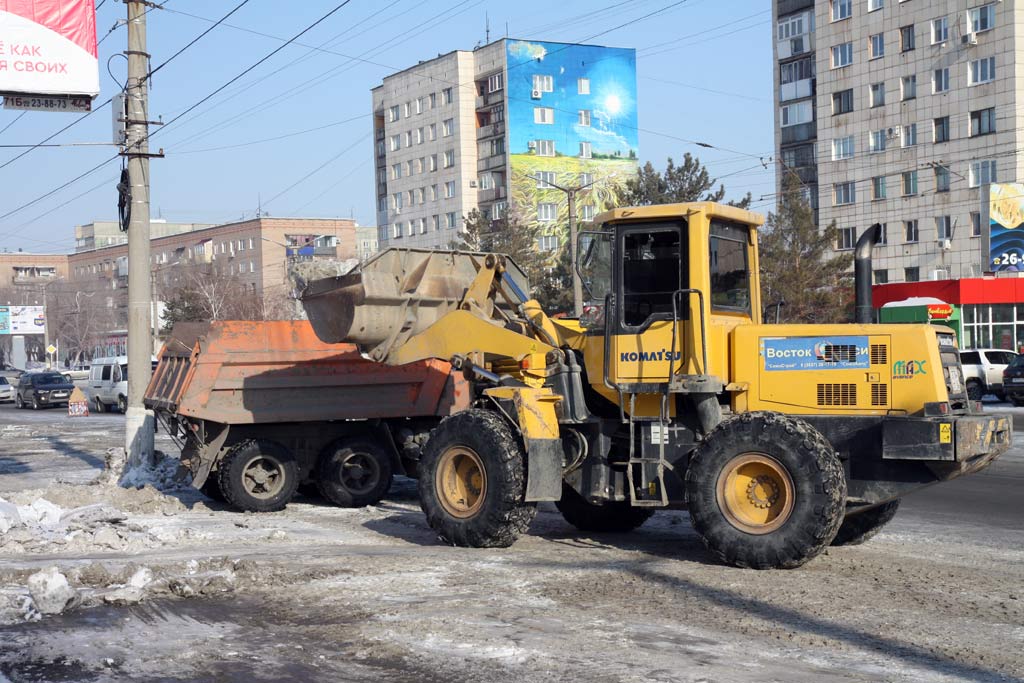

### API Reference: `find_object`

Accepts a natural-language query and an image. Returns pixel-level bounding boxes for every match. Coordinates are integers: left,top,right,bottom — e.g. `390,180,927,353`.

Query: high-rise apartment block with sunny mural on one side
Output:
372,39,638,250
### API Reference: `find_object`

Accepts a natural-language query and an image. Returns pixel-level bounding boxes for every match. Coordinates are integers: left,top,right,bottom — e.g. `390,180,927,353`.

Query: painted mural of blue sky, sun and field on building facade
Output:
506,41,639,246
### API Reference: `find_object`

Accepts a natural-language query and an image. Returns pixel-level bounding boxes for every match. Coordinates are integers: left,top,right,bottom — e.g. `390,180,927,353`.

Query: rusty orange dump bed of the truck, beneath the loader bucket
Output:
144,321,468,425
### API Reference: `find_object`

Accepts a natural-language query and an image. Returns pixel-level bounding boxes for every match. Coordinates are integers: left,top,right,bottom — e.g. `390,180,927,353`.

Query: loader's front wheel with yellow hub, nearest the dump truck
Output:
419,410,537,548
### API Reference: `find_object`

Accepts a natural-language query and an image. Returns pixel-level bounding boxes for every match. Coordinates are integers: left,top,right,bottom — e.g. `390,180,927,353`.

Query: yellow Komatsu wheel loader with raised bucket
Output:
302,203,1012,568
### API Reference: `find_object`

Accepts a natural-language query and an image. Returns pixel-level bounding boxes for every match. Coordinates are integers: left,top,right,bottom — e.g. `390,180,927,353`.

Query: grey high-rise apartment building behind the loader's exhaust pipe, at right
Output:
773,0,1007,284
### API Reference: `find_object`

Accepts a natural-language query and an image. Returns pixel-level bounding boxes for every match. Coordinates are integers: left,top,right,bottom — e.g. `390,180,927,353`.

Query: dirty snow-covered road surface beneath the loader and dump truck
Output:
0,405,1024,683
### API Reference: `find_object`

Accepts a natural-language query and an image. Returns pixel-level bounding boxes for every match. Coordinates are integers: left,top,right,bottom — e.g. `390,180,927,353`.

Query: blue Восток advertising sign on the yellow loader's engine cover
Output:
761,337,870,371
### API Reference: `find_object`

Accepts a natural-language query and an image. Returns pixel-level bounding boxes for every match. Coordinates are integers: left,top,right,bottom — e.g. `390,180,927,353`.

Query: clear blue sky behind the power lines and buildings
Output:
0,0,774,252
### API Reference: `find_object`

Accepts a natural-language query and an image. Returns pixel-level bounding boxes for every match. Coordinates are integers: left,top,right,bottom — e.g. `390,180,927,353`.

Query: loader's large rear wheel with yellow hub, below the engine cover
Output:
686,412,846,569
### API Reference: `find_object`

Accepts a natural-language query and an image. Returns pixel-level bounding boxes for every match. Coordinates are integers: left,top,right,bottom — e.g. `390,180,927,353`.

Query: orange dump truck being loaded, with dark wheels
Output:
145,321,470,512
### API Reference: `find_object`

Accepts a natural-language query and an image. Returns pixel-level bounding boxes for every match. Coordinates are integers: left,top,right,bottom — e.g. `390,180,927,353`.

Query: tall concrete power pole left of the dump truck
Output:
123,0,154,463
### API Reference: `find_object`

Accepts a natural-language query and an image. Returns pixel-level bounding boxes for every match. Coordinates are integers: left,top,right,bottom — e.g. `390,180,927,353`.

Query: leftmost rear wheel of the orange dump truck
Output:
217,439,299,512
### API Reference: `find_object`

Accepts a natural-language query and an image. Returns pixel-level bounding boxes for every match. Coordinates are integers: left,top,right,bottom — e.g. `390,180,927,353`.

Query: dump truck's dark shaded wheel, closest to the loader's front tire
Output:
316,439,392,508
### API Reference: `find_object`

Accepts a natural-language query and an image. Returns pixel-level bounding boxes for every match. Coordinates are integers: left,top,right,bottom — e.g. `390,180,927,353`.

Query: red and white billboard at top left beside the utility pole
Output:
0,0,99,97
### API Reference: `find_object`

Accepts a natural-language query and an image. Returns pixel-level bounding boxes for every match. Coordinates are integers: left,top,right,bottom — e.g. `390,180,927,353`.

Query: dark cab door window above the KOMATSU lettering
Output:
621,225,689,328
